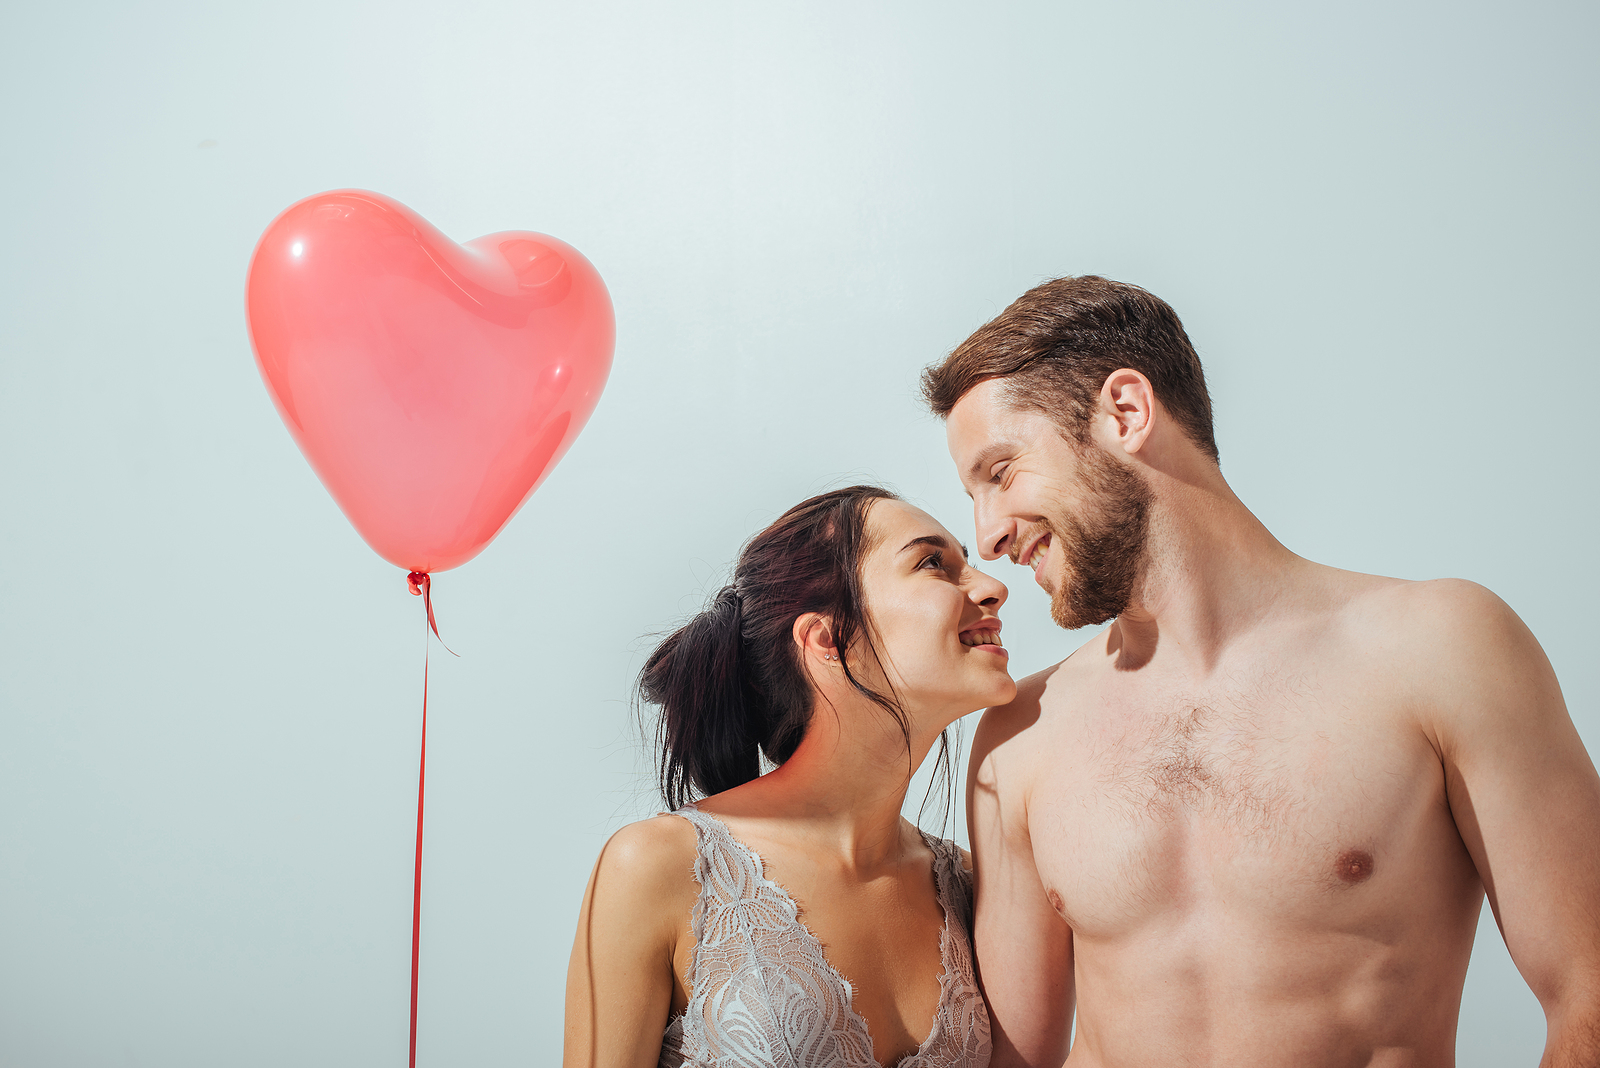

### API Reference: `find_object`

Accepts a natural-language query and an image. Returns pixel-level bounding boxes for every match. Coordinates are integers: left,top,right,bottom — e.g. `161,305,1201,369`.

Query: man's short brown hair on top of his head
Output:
922,275,1218,460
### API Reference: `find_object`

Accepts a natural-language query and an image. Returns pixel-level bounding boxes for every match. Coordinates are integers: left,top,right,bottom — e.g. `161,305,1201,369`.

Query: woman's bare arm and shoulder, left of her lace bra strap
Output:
562,815,696,1068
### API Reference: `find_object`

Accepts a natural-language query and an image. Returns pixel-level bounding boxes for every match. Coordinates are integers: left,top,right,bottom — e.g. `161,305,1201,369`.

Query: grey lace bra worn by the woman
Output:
659,806,989,1068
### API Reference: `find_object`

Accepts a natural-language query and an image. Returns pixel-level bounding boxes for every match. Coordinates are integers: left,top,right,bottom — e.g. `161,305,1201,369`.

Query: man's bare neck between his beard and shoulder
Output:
1109,467,1307,673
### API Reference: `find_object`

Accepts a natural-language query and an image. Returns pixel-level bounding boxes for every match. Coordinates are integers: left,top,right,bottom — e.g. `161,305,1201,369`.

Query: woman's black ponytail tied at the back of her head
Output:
638,585,765,809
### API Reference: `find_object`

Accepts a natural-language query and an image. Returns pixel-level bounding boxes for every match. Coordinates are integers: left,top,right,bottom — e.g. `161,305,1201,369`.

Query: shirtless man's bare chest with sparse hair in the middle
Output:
1026,670,1451,937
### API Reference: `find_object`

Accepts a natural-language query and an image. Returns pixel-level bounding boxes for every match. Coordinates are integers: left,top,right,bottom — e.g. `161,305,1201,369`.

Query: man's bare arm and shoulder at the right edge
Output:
1419,582,1600,1068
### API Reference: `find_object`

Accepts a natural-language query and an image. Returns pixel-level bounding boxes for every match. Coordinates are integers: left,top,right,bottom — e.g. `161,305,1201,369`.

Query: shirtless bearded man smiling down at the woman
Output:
923,277,1600,1068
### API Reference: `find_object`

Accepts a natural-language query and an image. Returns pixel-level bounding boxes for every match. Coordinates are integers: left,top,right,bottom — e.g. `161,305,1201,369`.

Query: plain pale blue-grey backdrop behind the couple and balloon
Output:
0,0,1600,1068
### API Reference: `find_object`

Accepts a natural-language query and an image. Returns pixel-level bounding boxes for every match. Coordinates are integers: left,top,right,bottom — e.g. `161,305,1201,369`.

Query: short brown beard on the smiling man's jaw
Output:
1046,444,1150,630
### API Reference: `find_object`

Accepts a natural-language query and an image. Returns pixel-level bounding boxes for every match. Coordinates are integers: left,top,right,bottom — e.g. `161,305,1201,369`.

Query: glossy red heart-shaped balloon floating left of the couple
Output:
246,189,616,572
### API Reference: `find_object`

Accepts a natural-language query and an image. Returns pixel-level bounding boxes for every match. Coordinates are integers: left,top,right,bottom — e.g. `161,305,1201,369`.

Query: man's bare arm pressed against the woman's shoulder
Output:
966,673,1074,1068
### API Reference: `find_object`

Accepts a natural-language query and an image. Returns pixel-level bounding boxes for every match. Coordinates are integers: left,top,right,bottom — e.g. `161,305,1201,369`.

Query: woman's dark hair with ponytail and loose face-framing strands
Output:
638,486,950,809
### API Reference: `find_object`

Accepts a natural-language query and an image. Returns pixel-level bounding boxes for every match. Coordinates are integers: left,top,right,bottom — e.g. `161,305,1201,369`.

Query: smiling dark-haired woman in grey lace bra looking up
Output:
565,486,1016,1068
